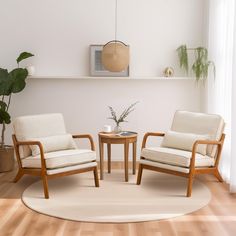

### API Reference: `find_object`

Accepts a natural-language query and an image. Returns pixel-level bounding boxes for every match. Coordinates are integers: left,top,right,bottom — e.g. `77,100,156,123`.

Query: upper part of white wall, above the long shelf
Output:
0,0,205,76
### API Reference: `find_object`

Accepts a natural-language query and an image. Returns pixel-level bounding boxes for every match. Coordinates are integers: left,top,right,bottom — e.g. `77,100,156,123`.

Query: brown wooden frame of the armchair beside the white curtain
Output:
137,133,225,197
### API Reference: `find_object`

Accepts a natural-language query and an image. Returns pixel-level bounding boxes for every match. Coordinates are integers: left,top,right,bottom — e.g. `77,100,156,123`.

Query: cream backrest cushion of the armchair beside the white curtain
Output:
171,111,225,157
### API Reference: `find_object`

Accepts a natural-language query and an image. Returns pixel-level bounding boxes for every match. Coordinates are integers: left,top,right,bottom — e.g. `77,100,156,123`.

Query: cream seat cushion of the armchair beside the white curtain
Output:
141,147,215,168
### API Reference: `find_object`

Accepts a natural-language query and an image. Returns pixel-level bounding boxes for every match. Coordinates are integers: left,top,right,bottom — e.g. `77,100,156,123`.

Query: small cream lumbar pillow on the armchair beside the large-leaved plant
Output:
30,134,77,156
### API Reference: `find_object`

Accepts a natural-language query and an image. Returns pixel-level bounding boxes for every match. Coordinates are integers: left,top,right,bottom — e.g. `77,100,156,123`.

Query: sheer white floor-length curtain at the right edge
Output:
207,0,236,192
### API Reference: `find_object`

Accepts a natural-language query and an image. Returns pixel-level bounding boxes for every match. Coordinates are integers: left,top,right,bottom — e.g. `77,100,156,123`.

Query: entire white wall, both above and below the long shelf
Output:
0,0,204,158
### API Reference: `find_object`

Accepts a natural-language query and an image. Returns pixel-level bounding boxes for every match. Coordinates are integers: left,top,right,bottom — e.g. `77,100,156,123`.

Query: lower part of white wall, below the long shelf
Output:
8,79,201,159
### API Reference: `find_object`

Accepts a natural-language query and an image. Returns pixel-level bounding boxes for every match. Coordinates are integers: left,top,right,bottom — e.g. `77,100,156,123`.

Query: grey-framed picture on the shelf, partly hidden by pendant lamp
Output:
90,45,129,77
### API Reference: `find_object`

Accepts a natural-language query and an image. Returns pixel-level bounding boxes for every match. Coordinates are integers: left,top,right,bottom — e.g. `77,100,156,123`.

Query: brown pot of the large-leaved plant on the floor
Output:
0,145,15,172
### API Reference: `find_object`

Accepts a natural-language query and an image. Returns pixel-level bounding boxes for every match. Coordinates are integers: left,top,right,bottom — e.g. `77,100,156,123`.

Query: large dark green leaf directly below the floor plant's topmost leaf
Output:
9,68,28,93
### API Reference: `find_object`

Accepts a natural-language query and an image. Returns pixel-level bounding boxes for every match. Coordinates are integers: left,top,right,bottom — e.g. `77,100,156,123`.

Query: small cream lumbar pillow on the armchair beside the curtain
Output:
161,131,210,155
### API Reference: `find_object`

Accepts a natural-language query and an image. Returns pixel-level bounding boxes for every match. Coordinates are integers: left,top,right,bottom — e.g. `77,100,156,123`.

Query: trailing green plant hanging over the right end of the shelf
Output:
177,45,215,82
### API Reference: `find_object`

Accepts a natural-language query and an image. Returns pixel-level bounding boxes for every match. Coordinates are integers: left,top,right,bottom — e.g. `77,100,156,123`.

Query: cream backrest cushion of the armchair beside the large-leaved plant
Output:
13,113,74,158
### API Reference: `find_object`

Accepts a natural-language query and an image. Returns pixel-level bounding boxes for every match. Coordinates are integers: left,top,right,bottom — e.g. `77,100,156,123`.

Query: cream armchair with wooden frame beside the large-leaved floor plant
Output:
12,114,99,198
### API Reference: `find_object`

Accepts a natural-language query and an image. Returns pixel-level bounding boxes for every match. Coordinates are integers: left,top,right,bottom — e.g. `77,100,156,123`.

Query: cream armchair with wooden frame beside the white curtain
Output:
137,111,225,197
